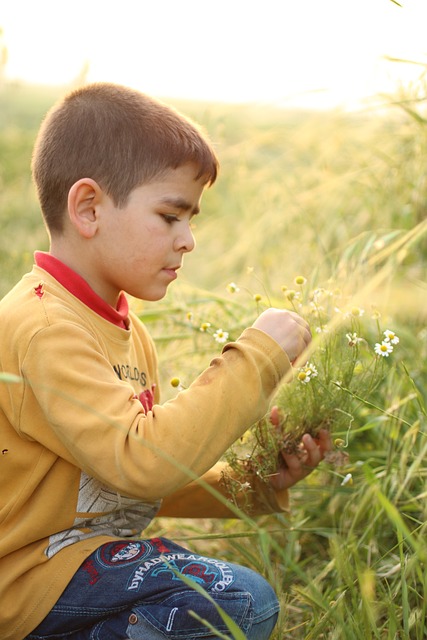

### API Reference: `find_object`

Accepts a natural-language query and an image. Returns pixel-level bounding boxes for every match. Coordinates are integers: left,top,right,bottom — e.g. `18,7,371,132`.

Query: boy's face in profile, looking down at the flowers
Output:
92,164,204,306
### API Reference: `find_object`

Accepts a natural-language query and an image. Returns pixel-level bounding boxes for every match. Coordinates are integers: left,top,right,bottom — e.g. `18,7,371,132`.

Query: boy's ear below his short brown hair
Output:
68,178,104,239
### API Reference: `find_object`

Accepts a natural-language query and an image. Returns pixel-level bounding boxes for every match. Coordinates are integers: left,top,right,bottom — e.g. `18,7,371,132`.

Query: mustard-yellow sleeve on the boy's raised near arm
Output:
19,323,291,502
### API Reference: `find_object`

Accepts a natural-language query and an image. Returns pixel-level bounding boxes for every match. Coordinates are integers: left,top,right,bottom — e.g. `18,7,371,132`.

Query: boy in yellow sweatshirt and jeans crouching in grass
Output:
0,84,329,640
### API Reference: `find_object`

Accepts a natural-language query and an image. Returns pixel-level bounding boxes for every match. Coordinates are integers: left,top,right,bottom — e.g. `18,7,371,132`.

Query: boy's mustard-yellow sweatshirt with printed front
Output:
0,266,290,640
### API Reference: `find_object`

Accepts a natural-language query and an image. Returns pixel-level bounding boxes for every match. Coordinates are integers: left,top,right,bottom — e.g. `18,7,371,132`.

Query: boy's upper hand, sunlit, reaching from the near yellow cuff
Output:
252,308,311,364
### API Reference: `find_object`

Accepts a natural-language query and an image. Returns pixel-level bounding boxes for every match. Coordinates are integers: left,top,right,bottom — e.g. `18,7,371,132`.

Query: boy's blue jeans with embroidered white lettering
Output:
26,538,279,640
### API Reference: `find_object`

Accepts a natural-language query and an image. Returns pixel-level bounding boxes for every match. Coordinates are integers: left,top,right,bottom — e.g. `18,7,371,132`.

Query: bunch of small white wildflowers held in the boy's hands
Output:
222,276,399,495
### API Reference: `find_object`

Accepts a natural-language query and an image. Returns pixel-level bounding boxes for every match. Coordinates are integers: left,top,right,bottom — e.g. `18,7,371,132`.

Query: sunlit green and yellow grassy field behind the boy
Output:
0,82,427,640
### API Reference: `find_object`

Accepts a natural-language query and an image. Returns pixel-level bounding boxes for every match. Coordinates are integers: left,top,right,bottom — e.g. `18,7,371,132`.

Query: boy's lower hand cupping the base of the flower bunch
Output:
270,407,332,491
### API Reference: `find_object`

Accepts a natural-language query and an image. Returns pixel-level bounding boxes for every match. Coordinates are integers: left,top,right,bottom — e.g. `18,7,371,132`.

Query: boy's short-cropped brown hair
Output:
32,83,218,232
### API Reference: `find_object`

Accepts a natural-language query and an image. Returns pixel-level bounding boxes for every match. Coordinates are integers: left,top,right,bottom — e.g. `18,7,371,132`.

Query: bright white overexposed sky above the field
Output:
0,0,427,108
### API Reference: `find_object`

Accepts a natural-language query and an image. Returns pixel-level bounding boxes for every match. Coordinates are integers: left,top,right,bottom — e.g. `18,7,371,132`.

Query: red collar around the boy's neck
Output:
34,251,129,329
